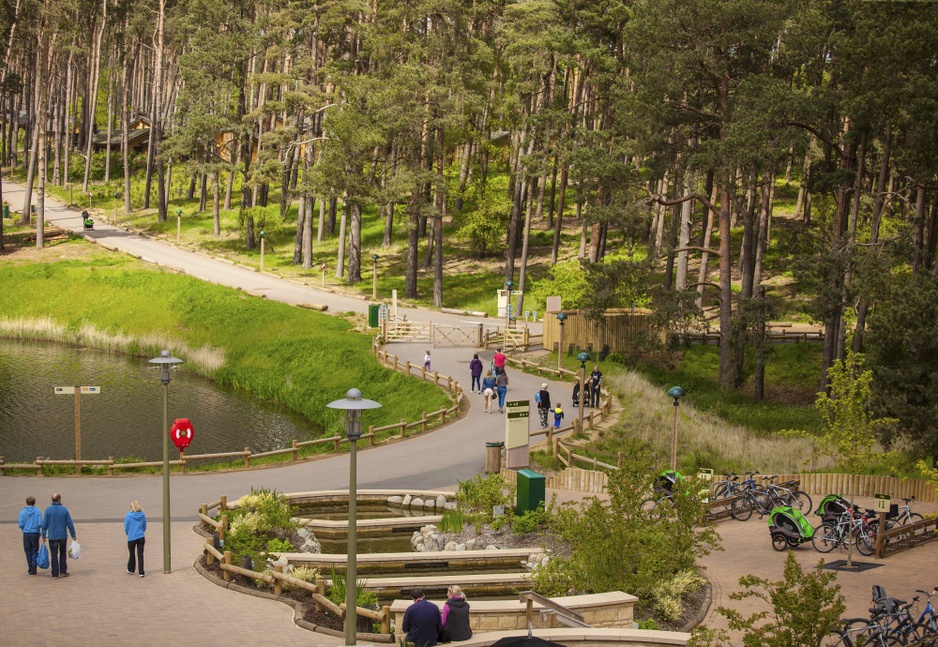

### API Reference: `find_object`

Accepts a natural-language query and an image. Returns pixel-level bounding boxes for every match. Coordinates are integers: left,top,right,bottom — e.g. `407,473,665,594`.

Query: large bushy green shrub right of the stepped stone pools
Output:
534,452,718,612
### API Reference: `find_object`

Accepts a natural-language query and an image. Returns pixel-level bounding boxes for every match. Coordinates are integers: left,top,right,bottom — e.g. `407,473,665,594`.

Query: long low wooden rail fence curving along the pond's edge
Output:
0,348,464,476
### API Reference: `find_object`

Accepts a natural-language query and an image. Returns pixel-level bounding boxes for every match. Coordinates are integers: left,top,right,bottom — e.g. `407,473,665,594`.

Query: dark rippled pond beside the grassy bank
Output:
0,339,321,463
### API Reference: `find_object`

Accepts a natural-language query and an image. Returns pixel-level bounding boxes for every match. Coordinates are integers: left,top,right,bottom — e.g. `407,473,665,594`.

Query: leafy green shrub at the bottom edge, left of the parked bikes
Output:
691,551,846,647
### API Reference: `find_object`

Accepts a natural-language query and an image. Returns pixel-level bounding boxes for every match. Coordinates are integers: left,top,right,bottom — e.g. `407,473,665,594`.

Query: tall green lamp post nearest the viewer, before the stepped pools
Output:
326,389,381,645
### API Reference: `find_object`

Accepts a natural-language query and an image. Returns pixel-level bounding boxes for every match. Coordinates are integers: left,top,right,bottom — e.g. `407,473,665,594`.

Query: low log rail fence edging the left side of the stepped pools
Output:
199,496,391,638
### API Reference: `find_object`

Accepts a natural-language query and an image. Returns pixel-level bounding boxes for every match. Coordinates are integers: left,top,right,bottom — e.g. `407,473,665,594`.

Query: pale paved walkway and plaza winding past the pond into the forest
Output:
0,184,938,647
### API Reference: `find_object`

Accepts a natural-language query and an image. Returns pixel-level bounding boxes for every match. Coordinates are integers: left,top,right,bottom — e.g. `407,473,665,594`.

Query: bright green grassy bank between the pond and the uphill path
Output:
0,240,450,435
